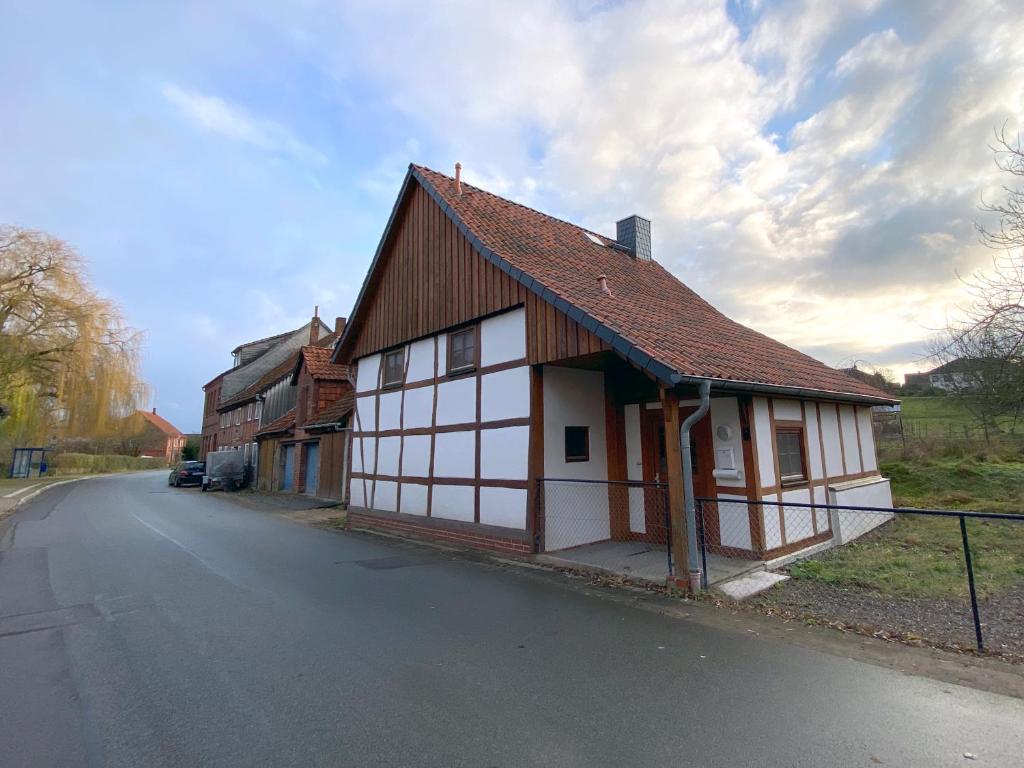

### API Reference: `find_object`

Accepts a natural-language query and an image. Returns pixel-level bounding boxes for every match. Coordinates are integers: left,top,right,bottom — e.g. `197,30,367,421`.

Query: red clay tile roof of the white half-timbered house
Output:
403,165,892,401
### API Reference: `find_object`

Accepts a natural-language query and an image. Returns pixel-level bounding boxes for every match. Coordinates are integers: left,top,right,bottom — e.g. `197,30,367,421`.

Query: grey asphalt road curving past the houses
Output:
0,474,1024,768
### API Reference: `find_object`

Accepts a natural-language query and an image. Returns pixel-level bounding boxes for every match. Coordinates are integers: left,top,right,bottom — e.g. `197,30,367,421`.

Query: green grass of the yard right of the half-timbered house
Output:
790,458,1024,597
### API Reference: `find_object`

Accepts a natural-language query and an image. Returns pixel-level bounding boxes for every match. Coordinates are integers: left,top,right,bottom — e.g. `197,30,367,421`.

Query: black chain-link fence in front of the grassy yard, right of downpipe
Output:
697,499,1024,651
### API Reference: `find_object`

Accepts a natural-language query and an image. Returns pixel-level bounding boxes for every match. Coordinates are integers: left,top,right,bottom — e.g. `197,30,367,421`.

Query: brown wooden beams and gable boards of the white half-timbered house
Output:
336,172,884,563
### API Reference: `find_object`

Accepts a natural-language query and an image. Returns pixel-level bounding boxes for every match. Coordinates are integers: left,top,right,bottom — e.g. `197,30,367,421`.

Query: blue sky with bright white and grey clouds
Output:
0,0,1024,430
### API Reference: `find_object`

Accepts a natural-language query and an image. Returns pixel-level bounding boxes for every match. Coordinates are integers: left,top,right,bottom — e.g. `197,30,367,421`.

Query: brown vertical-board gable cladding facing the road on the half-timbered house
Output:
352,184,527,359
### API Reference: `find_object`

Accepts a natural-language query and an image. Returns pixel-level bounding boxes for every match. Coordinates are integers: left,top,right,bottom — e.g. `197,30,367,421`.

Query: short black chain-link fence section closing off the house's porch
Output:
536,477,672,574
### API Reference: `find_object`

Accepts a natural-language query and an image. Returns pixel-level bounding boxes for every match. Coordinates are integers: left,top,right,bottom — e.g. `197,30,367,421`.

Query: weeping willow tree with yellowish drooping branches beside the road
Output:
0,226,145,444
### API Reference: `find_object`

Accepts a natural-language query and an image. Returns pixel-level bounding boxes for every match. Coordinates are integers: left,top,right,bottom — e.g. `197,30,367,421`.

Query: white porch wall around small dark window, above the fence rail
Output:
544,366,608,481
